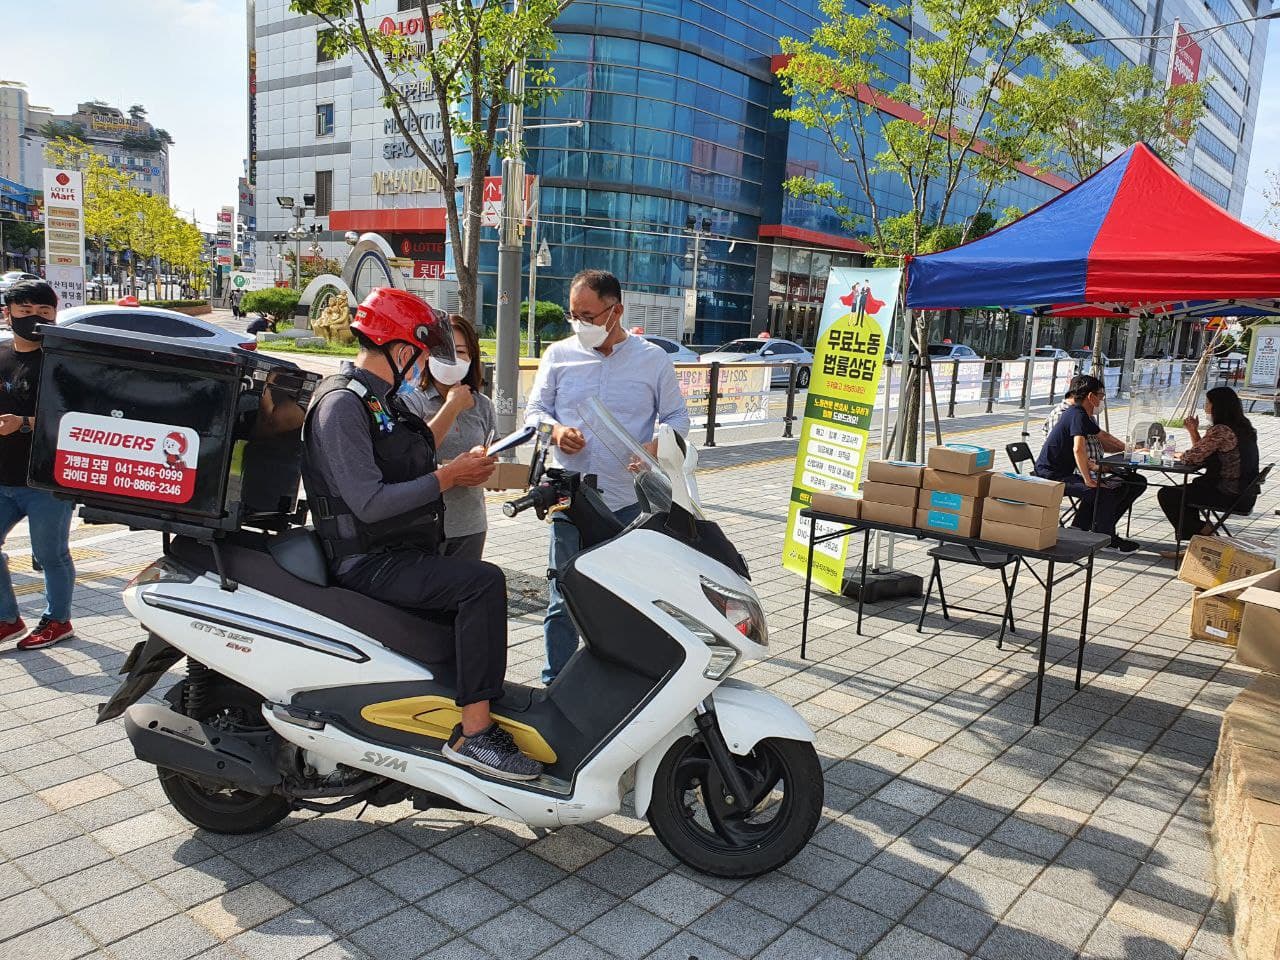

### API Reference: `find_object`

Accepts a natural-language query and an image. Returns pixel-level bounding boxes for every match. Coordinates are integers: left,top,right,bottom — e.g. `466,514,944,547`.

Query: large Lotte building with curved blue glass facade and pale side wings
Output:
256,0,1266,344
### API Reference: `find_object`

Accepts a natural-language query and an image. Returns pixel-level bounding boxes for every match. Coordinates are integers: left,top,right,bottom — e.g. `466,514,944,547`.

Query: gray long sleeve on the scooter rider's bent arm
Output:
307,390,440,524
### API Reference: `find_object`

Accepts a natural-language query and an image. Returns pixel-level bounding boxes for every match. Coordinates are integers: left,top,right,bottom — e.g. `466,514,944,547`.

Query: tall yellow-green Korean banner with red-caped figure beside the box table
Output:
782,266,902,593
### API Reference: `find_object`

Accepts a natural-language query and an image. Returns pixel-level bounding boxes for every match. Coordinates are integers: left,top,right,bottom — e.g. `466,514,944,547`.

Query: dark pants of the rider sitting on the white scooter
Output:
338,550,507,707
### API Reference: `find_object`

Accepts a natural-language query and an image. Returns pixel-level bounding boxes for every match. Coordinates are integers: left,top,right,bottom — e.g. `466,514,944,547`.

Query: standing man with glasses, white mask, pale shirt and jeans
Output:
525,270,689,685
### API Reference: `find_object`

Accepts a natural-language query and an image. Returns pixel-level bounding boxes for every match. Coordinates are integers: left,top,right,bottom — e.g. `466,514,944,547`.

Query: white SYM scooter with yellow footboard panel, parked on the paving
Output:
99,415,823,877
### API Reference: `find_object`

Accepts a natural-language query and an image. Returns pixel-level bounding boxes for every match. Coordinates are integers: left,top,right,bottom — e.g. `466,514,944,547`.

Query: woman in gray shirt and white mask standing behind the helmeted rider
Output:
401,314,498,559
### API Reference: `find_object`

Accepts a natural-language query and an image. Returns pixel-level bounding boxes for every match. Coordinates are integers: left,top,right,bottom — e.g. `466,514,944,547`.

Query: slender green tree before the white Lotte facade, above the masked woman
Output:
289,0,568,321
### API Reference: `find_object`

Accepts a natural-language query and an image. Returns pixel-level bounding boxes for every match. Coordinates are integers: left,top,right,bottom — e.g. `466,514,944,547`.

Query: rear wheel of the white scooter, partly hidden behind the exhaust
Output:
156,684,292,833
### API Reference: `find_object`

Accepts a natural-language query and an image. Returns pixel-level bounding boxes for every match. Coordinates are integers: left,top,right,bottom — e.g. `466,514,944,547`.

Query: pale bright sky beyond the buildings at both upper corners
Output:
0,0,1280,229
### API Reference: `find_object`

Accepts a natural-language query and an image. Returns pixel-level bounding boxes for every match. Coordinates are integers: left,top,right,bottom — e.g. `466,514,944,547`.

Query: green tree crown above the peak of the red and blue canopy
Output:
1005,60,1204,180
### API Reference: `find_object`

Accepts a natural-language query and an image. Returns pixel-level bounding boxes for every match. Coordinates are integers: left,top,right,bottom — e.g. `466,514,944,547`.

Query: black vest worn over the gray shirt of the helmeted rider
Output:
302,370,444,561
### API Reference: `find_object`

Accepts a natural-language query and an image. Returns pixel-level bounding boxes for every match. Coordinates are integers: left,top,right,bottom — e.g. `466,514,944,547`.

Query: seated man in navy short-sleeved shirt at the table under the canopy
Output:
1036,376,1147,553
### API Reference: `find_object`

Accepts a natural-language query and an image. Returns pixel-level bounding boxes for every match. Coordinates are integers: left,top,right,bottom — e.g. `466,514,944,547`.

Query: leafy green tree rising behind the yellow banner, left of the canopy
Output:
777,0,1079,451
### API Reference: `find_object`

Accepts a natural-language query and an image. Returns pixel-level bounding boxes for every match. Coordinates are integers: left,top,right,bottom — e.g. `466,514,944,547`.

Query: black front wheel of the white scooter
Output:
649,737,823,878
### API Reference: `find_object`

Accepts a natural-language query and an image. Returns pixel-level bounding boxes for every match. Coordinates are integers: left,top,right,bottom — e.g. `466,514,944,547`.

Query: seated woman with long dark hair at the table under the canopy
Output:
1156,387,1258,559
